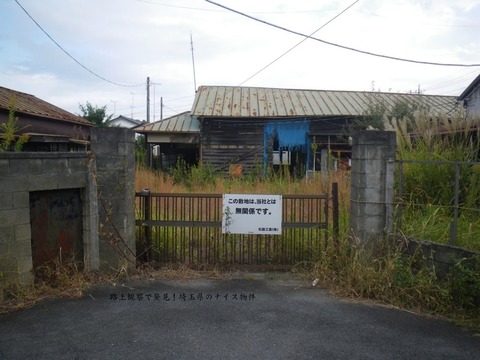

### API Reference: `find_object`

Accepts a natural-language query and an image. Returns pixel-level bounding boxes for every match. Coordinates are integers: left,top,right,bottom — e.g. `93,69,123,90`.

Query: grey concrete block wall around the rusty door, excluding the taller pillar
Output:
0,153,98,283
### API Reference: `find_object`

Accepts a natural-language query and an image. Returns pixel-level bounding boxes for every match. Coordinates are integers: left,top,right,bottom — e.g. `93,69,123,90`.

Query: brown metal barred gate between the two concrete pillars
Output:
136,191,338,269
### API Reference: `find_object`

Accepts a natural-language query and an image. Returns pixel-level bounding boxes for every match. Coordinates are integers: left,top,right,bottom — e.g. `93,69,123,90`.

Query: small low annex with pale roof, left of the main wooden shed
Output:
133,111,200,170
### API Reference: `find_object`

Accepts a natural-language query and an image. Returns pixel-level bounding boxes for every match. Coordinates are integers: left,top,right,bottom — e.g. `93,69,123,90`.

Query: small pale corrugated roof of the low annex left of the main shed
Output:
133,111,200,133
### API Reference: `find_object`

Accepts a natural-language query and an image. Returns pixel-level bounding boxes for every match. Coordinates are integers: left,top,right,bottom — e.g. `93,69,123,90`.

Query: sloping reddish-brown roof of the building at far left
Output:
0,86,93,126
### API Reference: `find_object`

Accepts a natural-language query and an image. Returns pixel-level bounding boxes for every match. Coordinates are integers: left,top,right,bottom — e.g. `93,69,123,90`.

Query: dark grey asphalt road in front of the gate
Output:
0,277,480,360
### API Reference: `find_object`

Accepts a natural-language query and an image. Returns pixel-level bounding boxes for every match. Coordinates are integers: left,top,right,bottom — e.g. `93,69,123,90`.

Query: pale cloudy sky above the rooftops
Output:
0,0,480,121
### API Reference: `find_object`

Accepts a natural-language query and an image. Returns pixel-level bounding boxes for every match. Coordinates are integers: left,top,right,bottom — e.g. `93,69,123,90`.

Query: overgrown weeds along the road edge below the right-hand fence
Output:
313,236,480,332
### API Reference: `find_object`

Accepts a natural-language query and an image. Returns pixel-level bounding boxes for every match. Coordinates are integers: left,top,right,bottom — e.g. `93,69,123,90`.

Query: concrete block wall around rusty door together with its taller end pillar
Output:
0,128,135,284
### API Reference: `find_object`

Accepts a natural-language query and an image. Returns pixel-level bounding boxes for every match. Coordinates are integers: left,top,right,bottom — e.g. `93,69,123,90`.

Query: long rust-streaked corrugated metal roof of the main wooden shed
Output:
191,86,457,117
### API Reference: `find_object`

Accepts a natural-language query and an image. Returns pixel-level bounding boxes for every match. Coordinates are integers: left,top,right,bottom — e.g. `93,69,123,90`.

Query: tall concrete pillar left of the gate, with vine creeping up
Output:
90,128,136,270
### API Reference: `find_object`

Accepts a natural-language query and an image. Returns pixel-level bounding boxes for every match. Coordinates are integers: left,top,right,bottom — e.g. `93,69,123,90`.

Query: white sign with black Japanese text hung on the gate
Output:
222,194,282,235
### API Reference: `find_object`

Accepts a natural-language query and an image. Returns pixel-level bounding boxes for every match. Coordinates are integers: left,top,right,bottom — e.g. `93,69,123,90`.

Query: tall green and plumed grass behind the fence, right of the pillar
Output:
389,112,480,250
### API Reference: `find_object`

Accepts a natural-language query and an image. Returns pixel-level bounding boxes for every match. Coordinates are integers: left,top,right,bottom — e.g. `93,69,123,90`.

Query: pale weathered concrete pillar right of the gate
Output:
350,131,396,243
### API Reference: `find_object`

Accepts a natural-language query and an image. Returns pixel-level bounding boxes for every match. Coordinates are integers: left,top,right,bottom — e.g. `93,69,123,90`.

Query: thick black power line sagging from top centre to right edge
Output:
205,0,480,67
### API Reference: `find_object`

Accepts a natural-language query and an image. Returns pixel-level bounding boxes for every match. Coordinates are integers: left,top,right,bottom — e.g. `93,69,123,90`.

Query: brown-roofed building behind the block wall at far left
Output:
0,87,93,151
